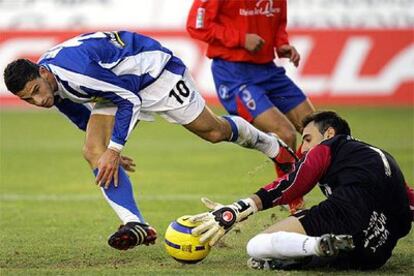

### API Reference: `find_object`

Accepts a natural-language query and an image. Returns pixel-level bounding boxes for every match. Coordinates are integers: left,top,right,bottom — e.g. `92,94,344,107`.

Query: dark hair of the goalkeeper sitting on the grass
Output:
302,111,351,135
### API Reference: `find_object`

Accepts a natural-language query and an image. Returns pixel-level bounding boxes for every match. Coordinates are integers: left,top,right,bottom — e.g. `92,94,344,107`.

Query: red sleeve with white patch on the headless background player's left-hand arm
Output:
187,0,245,48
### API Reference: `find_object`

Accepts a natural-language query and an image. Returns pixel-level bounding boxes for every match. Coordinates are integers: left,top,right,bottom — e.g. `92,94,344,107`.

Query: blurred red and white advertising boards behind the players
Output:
0,0,414,106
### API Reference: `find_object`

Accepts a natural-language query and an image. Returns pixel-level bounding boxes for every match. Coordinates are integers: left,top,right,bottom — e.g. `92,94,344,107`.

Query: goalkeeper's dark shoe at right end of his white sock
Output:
316,234,355,257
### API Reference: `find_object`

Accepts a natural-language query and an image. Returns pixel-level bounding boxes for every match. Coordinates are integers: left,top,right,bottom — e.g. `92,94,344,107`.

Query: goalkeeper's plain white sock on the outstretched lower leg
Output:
247,232,319,259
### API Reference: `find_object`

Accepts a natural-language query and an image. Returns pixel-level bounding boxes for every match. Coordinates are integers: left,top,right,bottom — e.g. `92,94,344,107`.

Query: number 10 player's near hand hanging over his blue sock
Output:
95,149,121,189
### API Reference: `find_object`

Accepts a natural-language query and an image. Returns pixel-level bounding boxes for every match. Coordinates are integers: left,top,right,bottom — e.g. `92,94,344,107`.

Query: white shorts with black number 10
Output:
91,70,206,125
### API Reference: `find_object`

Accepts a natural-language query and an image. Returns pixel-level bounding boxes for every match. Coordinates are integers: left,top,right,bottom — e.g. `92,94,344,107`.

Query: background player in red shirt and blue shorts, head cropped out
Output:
187,0,314,172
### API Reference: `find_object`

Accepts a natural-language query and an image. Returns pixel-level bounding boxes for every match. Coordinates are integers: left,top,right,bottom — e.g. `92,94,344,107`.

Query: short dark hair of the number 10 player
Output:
3,59,40,94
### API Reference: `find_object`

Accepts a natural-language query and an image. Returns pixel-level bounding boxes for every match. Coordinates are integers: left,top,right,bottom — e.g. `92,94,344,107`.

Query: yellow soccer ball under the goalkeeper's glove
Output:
164,216,210,264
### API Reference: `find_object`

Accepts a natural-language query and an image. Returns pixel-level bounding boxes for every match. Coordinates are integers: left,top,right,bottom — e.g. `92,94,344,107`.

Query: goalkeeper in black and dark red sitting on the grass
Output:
191,111,413,269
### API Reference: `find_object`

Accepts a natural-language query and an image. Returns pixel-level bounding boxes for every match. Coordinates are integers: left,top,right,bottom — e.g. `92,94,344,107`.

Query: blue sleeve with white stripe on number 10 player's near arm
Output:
77,63,142,151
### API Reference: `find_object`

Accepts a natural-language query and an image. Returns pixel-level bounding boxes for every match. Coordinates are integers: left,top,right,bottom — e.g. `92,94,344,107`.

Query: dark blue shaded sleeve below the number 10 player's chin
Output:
55,97,91,131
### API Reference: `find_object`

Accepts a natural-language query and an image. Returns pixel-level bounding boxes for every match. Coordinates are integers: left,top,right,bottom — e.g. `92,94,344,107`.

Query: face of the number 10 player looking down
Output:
16,77,54,108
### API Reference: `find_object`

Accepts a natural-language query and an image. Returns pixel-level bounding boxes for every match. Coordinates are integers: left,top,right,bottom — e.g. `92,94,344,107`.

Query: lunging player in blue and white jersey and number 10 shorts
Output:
4,31,290,250
